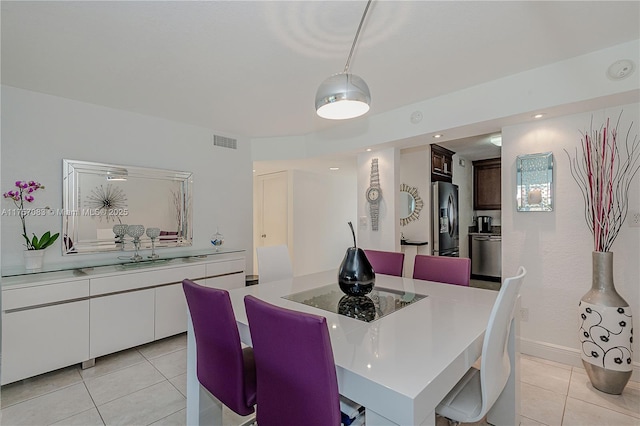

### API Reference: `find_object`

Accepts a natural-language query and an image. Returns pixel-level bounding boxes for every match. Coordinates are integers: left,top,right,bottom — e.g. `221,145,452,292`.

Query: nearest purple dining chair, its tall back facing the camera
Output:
244,295,341,426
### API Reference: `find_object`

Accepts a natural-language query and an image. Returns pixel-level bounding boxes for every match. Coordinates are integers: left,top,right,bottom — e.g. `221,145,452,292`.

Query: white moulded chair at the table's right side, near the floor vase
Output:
436,266,527,423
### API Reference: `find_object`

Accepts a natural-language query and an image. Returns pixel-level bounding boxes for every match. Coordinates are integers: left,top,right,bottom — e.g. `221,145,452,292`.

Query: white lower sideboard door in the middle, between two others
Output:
89,288,156,358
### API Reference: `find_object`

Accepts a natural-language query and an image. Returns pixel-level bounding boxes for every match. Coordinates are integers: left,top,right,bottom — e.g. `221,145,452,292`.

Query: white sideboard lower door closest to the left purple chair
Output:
155,283,188,340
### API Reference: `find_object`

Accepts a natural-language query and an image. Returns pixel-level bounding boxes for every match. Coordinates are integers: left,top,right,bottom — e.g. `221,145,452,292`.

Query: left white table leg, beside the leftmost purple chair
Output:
187,316,222,426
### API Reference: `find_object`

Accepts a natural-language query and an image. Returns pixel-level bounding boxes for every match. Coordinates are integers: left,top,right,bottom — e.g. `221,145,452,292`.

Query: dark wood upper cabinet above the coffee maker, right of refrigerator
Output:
473,158,502,210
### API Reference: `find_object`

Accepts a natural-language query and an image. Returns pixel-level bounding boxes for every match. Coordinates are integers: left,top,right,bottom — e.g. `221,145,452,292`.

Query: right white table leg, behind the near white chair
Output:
487,310,520,426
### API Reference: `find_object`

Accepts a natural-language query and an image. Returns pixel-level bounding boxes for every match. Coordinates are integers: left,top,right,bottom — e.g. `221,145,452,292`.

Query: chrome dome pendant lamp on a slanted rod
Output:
316,0,371,120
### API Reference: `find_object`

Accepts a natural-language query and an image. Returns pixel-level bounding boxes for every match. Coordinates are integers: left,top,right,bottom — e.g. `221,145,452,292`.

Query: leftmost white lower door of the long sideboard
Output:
2,300,90,385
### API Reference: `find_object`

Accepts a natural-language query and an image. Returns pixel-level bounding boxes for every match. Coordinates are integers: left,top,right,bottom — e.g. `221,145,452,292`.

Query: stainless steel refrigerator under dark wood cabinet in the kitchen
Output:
431,181,460,257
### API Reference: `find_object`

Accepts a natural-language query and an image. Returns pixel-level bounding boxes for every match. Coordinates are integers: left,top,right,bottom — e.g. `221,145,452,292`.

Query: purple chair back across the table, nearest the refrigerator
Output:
413,254,471,286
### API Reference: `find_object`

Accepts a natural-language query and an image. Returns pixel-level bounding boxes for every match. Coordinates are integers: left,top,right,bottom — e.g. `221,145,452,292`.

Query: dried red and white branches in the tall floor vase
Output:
565,113,640,252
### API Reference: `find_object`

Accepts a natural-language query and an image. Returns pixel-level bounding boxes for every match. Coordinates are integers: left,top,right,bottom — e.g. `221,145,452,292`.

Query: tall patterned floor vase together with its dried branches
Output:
565,113,640,394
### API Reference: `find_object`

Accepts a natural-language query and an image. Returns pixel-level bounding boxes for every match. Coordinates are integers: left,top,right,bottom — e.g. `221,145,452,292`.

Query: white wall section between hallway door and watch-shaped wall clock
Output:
293,170,358,276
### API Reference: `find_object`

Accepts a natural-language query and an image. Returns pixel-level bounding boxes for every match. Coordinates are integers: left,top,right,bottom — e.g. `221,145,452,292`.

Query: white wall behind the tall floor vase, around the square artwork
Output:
502,104,640,372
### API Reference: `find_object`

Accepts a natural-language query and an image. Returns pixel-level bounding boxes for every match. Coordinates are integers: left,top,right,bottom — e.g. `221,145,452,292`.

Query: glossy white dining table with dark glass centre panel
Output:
187,270,520,426
